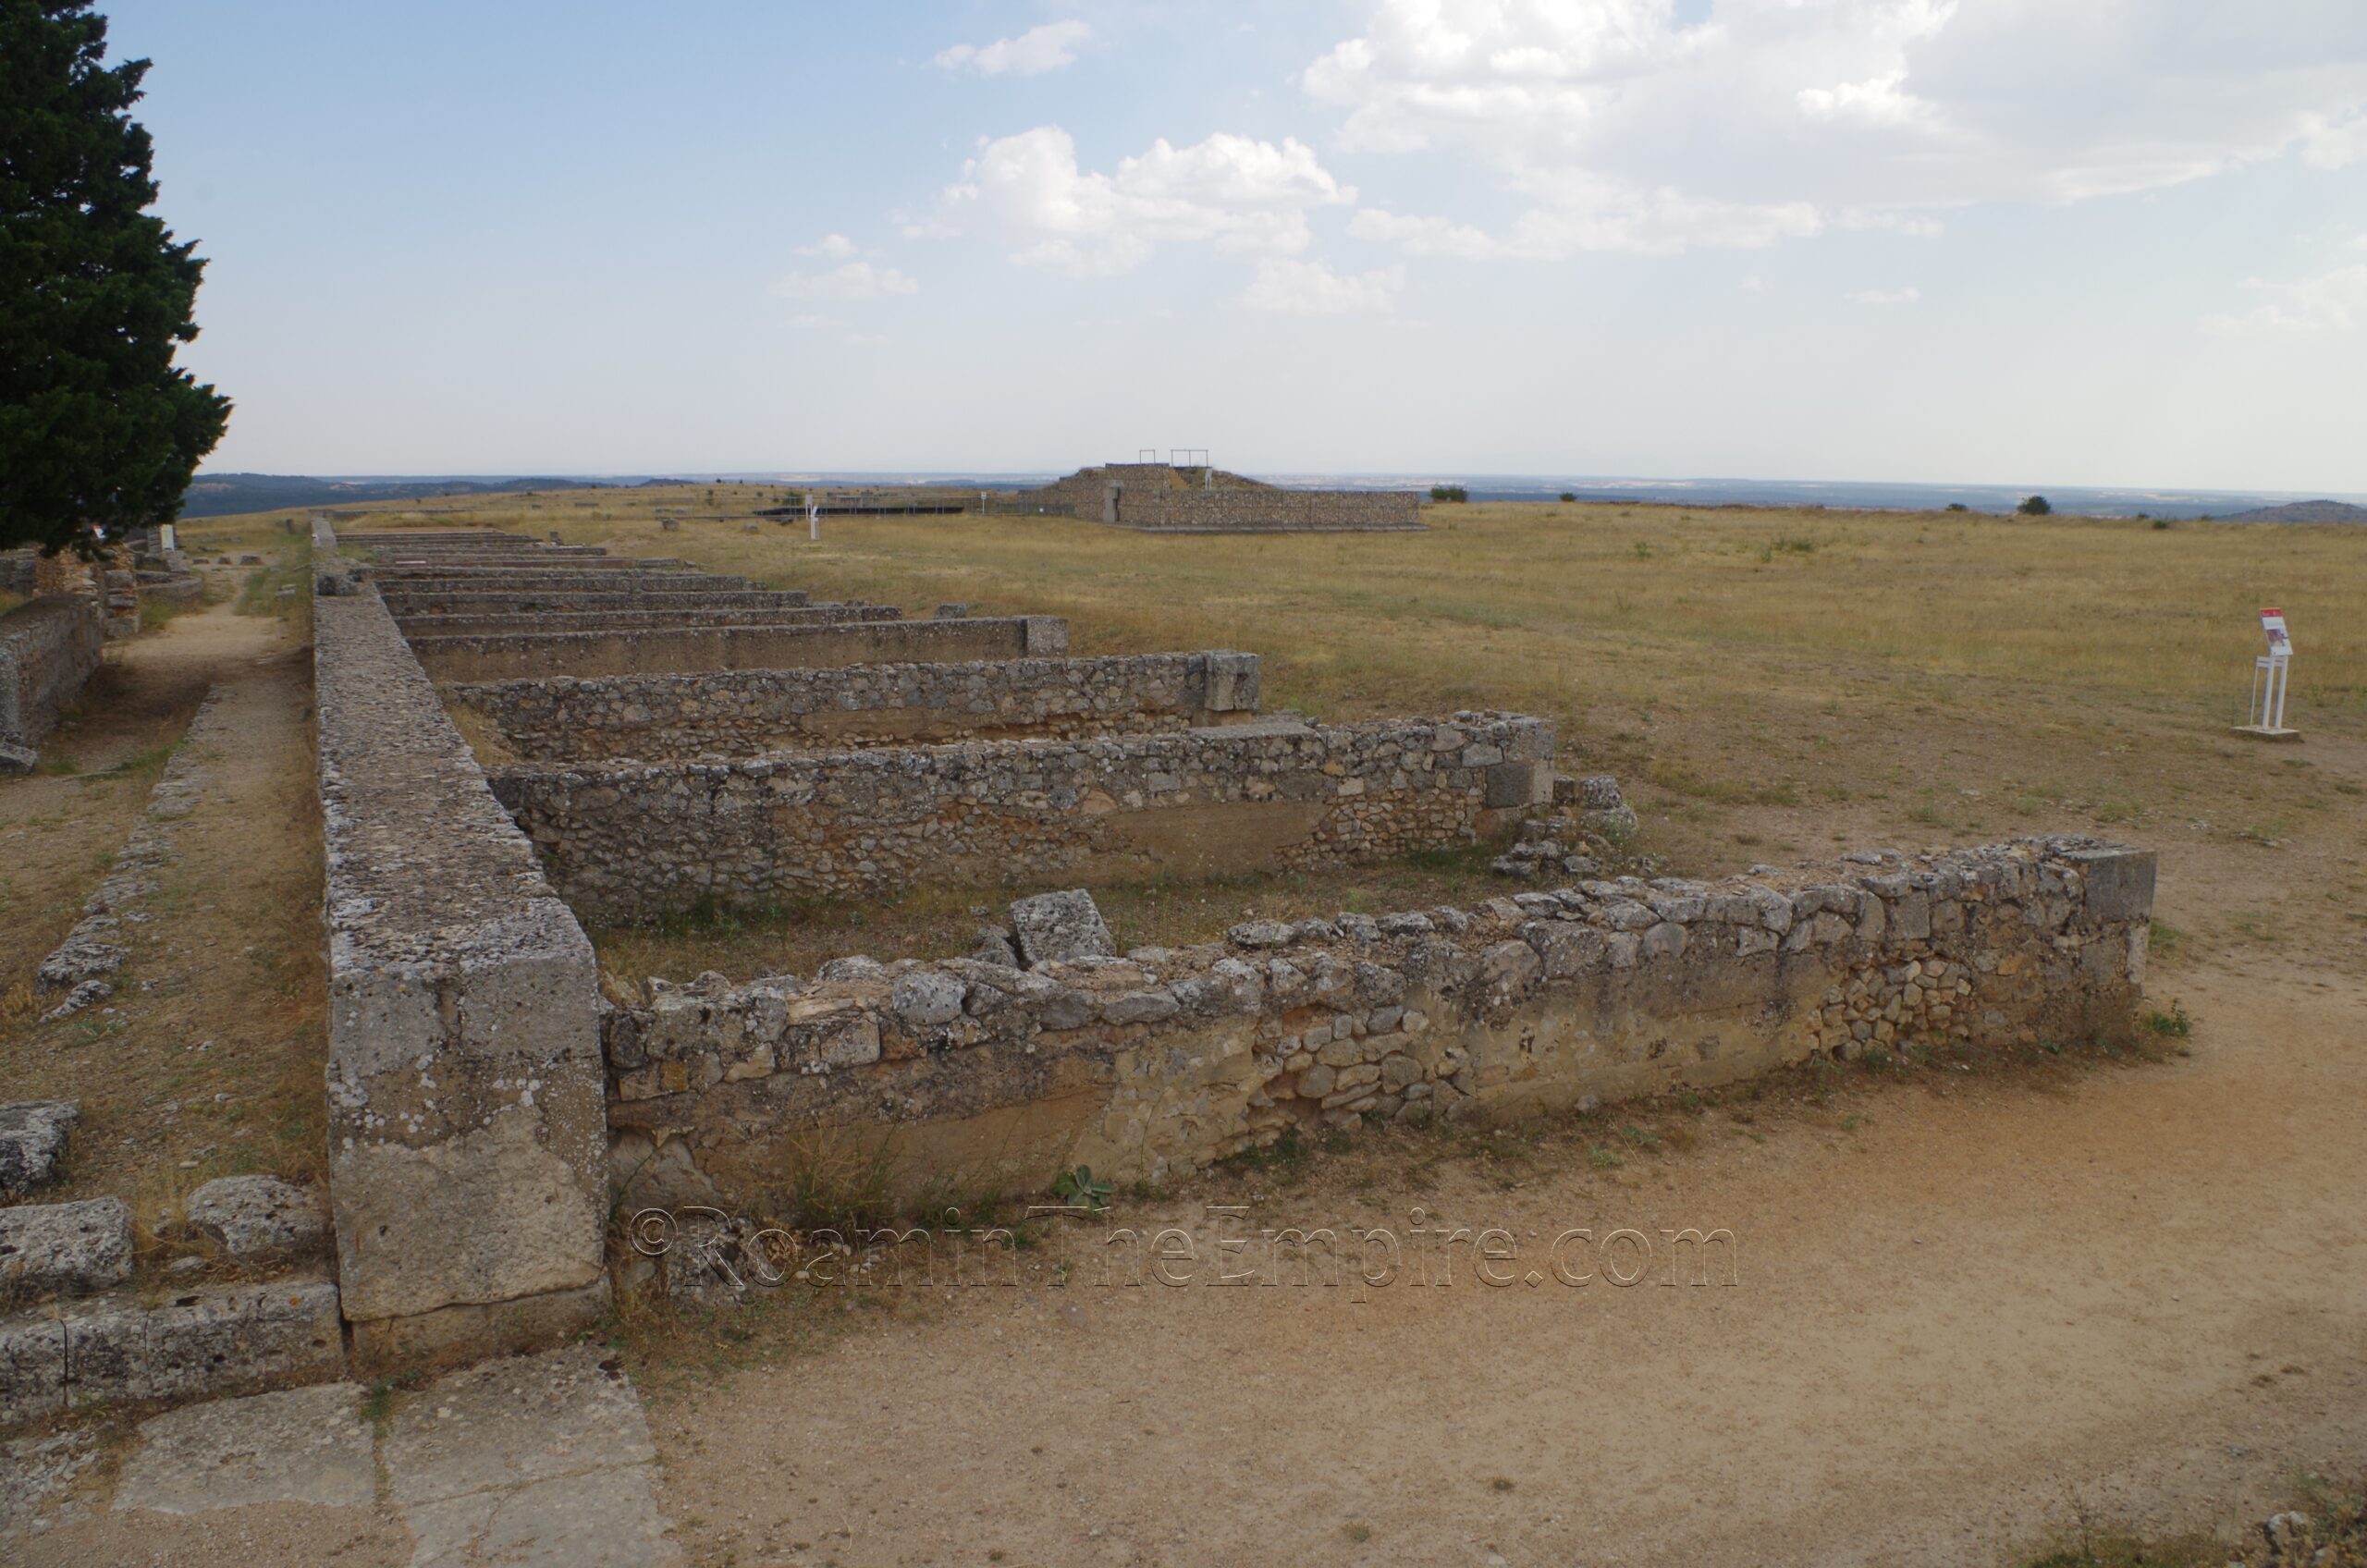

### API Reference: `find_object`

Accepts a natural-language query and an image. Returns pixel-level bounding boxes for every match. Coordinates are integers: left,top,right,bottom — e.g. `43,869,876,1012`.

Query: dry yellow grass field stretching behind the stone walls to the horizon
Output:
300,485,2367,989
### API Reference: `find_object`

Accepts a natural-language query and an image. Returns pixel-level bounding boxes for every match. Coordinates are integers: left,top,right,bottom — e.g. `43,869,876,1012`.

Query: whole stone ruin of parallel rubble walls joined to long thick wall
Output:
272,519,2152,1366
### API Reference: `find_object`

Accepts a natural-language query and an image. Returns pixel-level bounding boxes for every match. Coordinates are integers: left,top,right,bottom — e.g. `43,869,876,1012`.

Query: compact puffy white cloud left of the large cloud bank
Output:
932,126,1356,277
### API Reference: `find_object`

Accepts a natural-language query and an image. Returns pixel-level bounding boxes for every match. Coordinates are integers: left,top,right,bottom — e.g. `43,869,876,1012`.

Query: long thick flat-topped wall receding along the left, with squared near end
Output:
313,587,606,1365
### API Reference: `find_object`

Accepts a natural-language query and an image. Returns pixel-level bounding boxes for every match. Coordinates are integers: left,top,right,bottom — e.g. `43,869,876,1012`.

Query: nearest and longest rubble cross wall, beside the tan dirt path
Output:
601,839,2154,1196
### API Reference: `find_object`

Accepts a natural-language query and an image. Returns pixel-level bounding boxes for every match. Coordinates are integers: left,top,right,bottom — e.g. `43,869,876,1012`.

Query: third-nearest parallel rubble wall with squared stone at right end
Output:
448,654,1257,763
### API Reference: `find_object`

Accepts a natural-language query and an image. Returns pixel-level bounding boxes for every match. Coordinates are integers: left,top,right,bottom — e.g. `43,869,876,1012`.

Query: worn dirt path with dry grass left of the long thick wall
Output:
0,592,322,1218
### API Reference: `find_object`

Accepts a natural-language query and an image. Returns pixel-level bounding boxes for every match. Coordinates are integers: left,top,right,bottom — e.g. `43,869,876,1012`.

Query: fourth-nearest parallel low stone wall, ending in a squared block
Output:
411,616,1068,680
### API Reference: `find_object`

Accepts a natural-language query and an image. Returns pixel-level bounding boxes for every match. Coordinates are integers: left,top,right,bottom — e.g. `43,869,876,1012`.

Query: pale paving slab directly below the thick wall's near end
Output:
384,1345,681,1568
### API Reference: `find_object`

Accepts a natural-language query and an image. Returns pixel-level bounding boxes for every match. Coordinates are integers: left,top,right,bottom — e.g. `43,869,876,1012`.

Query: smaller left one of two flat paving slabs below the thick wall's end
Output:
116,1383,379,1513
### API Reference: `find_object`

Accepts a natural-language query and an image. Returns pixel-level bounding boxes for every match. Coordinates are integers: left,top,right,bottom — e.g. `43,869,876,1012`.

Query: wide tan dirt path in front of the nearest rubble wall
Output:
654,937,2367,1568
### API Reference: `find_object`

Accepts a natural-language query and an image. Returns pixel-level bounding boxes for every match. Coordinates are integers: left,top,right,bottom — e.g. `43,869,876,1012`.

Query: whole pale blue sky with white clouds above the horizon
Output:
100,0,2367,493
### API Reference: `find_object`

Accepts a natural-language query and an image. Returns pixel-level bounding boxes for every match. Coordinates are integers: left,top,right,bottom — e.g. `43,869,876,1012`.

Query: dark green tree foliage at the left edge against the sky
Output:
0,0,229,552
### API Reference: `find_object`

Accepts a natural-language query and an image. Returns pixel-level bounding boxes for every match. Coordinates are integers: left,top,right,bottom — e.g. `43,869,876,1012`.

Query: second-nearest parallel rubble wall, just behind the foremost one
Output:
490,713,1552,924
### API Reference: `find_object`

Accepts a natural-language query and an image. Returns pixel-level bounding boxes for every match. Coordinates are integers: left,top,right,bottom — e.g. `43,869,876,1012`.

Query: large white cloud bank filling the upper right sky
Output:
1299,0,2367,258
